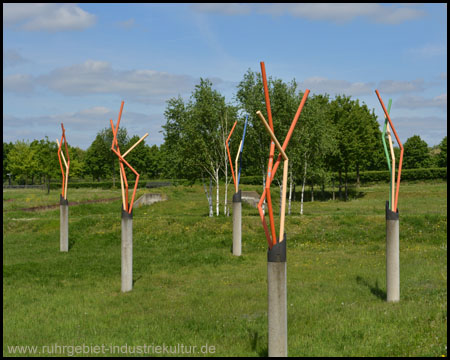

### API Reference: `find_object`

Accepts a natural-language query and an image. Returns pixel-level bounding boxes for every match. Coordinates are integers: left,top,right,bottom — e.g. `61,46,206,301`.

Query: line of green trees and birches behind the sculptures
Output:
3,69,447,211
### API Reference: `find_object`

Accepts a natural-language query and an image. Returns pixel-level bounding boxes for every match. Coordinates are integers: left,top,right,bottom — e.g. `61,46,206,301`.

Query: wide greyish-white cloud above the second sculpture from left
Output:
37,60,200,104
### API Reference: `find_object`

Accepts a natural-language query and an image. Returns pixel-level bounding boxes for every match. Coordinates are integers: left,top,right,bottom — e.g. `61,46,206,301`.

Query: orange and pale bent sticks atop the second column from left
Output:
110,101,148,214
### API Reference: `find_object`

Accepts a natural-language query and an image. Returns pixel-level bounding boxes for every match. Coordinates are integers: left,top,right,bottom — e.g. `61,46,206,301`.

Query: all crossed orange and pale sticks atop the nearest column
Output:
257,62,309,249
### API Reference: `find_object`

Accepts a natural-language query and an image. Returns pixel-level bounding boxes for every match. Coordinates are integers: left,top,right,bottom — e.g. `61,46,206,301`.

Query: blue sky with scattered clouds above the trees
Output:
3,3,447,149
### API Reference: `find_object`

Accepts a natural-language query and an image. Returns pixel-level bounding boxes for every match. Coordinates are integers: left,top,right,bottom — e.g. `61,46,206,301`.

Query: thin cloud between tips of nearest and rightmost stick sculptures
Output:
300,77,375,96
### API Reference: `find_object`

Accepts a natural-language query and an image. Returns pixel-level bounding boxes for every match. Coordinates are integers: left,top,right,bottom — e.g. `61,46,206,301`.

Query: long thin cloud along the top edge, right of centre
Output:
191,3,425,24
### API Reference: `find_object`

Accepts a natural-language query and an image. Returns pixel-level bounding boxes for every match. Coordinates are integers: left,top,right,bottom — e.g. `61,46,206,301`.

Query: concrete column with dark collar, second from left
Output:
121,209,133,292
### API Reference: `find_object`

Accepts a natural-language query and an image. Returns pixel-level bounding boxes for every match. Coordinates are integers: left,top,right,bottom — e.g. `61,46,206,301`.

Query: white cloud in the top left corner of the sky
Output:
3,3,96,31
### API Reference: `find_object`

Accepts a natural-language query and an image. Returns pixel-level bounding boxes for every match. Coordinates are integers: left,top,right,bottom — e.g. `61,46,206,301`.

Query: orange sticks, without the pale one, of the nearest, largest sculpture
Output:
258,62,309,249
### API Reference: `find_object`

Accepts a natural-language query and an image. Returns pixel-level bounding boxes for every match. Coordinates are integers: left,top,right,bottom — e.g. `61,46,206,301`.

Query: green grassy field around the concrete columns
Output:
3,182,447,356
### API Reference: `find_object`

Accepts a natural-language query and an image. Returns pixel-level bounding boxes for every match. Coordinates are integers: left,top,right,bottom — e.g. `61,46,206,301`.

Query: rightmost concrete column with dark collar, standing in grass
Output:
386,201,400,302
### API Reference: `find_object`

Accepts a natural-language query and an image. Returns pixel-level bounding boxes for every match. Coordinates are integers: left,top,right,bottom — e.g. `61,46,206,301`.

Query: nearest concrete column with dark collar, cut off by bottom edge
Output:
267,234,288,357
